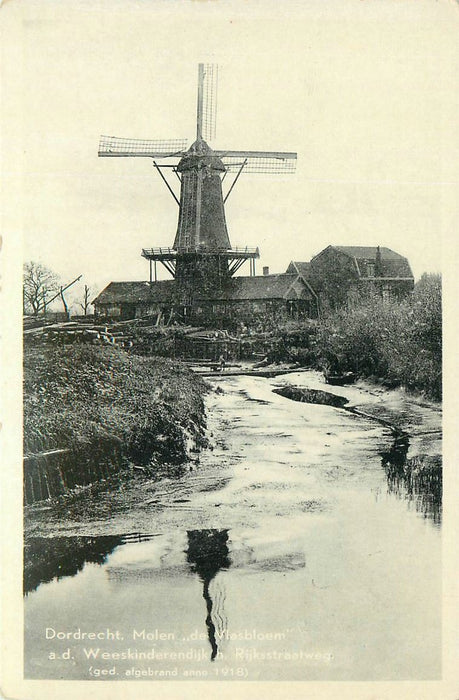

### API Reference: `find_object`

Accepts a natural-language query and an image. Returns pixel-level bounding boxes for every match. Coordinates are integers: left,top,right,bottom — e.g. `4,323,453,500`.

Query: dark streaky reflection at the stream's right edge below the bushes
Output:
381,433,443,525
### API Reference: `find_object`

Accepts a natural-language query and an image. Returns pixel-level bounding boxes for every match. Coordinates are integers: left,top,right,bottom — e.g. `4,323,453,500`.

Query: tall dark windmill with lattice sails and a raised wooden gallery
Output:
99,63,296,307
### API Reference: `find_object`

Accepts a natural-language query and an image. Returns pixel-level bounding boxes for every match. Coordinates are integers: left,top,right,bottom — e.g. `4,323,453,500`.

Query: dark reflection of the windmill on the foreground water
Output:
187,529,231,661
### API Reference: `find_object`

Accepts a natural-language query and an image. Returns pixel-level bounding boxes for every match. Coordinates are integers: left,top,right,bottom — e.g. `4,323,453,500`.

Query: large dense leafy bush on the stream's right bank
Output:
315,274,442,400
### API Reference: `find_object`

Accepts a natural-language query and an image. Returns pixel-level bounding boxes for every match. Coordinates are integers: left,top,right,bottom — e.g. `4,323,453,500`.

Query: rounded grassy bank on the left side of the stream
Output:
24,345,209,501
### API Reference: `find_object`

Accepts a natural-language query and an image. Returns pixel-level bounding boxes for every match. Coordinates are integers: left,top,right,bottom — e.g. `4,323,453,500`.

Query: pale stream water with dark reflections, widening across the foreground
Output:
25,372,441,680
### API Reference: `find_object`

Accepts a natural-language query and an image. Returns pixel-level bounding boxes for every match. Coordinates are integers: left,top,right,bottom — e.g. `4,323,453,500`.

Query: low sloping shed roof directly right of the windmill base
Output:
200,273,306,301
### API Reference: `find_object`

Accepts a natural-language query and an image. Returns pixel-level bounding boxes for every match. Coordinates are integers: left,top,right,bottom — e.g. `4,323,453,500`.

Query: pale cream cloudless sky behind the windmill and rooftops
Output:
2,0,459,308
